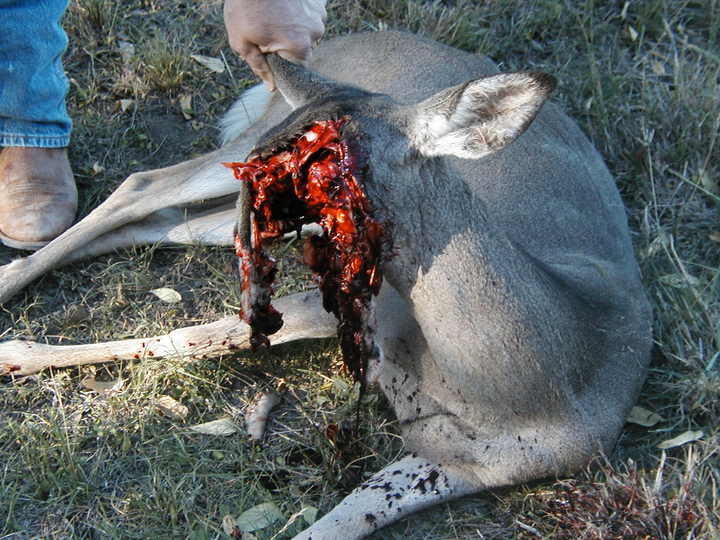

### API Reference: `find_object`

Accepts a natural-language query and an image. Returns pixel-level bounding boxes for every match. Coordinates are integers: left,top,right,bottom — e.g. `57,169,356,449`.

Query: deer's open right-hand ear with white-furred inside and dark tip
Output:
410,71,555,159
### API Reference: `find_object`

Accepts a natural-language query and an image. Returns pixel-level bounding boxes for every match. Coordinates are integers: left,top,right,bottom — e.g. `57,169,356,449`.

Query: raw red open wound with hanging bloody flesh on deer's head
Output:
225,119,384,385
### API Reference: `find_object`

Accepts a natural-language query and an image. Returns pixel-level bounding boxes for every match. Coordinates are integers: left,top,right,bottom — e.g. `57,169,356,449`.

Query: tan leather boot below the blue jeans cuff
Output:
0,146,77,249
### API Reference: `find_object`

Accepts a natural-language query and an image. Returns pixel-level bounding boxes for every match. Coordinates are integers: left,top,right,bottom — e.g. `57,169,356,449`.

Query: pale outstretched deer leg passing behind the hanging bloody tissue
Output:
0,291,337,375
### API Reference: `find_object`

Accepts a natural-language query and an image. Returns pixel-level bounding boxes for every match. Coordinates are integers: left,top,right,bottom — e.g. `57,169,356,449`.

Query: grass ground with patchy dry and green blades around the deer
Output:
0,0,720,540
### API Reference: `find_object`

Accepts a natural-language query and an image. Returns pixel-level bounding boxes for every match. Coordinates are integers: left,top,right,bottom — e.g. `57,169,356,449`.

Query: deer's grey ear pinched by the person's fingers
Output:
267,53,342,109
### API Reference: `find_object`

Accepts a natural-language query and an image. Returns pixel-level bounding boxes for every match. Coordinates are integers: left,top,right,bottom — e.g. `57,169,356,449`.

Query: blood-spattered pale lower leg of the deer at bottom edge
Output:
293,455,480,540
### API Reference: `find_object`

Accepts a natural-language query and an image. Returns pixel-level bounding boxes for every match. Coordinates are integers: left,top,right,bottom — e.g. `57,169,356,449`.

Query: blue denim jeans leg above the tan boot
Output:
0,0,72,148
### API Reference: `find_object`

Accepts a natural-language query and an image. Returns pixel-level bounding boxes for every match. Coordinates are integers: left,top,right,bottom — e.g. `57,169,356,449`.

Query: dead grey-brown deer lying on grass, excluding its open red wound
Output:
0,32,651,540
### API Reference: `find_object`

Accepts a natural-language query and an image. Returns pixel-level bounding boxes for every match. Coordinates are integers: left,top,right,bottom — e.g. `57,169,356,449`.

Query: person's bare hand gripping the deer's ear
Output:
223,0,327,91
